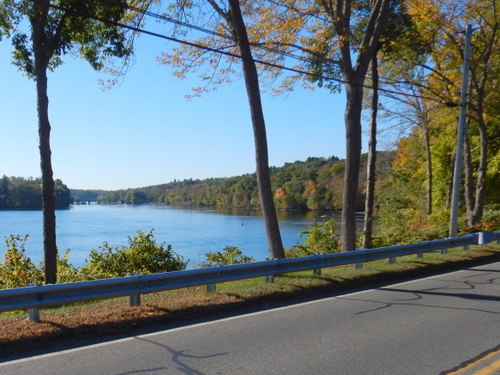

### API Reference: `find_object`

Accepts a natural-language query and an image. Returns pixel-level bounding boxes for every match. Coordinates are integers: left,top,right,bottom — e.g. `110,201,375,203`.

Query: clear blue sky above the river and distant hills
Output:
0,30,352,189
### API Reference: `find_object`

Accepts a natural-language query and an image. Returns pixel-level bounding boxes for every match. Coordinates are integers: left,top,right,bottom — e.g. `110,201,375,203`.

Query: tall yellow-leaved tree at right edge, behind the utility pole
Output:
406,0,500,225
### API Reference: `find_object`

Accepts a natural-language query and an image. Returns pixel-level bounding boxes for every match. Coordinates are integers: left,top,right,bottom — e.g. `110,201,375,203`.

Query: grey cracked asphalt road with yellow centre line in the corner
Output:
0,262,500,375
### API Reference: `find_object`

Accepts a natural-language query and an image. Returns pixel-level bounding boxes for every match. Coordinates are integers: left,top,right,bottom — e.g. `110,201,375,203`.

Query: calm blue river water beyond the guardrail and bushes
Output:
0,205,336,267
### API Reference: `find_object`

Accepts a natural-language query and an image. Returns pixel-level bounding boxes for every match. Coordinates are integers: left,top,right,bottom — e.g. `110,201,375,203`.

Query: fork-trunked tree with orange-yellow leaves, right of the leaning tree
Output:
241,0,391,251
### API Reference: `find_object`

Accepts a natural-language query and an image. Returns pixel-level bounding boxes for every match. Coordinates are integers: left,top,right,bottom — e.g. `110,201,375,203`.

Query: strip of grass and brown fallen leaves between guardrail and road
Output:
0,244,500,357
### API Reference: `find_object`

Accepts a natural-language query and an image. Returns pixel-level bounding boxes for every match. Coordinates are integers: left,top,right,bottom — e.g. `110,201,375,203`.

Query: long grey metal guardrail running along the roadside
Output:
0,232,500,318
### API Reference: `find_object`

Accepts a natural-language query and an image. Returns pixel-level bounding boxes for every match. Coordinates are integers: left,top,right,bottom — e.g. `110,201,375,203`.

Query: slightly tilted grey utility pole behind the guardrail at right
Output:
449,25,472,238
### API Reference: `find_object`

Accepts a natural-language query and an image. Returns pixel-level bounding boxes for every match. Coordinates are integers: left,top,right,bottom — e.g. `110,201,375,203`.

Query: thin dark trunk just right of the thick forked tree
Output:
363,54,379,249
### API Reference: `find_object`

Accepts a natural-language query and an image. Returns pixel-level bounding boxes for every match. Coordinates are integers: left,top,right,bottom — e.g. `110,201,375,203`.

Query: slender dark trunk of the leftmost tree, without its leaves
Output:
31,1,57,284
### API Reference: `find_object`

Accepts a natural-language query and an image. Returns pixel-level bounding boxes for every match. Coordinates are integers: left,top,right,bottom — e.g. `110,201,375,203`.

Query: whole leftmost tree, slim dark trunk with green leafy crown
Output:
0,0,148,283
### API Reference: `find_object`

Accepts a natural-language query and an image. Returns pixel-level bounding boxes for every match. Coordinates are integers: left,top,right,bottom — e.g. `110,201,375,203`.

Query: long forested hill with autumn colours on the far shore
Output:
98,152,393,210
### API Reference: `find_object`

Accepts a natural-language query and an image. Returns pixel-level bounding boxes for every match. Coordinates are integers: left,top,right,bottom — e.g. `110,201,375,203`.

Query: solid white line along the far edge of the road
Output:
0,266,496,367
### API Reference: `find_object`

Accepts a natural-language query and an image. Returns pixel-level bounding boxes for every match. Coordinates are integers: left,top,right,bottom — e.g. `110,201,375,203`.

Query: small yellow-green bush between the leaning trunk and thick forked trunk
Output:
286,219,339,258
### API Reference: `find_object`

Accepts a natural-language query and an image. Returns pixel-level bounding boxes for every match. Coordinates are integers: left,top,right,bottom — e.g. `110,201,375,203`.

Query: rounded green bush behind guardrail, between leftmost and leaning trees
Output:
81,230,187,279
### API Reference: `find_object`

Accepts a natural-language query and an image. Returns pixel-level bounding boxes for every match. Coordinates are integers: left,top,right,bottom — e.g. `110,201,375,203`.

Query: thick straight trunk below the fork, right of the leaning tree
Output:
341,78,363,251
